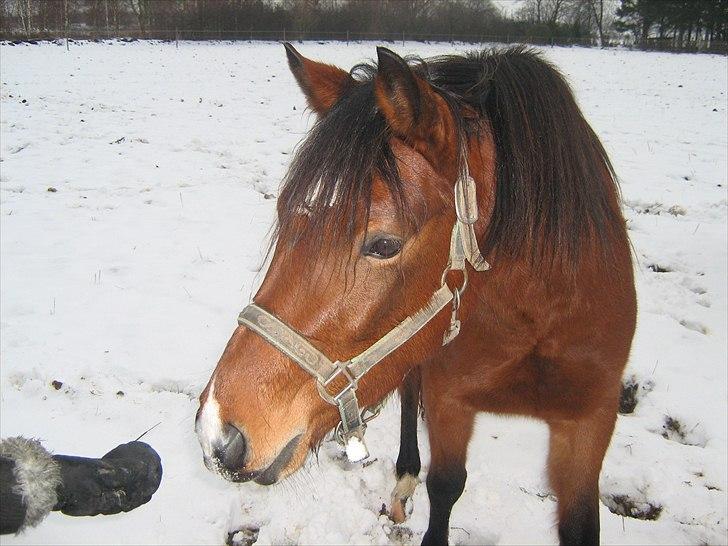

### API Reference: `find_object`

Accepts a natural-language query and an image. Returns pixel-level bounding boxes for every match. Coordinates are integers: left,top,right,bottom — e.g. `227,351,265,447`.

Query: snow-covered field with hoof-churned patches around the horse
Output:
0,42,728,544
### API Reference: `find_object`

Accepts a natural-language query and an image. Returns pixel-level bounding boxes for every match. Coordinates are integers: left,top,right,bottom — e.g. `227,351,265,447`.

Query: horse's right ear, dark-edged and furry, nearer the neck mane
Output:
375,47,454,159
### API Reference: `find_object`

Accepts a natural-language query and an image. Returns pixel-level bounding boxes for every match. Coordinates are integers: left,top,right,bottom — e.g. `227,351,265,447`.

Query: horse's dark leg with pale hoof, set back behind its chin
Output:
389,368,421,523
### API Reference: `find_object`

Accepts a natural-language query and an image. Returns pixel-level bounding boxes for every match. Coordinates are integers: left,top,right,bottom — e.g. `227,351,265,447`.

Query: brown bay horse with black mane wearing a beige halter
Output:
196,44,636,544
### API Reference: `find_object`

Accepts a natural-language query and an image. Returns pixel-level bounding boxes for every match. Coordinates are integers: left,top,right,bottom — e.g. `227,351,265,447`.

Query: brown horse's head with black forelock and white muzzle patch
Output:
196,44,494,484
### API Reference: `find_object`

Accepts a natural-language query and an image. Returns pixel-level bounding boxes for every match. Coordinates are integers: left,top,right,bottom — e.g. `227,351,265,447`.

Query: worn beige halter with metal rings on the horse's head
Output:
238,165,490,462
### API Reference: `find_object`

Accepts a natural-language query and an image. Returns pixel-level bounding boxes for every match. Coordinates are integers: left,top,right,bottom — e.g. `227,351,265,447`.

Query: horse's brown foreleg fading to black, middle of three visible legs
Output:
422,370,475,545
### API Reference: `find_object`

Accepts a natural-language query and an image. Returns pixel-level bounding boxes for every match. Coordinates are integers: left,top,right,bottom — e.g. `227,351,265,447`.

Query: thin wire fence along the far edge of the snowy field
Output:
0,28,728,54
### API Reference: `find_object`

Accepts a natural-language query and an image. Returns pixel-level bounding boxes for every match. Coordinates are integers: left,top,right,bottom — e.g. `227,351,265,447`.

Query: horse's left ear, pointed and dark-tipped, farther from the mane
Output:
283,42,354,114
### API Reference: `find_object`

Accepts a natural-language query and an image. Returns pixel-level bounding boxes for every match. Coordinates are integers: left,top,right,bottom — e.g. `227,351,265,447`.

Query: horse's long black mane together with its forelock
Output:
278,46,623,265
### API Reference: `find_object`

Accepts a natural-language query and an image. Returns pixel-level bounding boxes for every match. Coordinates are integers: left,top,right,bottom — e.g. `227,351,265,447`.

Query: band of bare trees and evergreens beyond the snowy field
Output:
0,0,728,48
